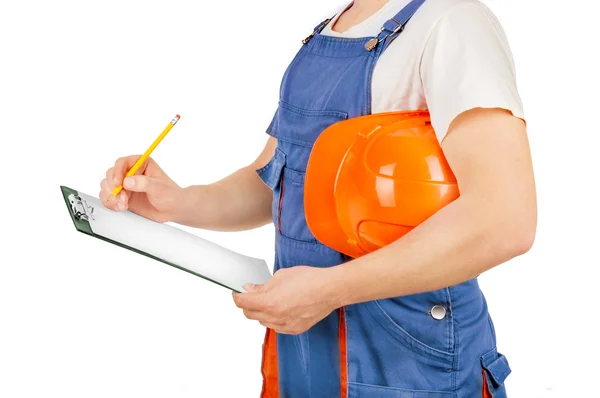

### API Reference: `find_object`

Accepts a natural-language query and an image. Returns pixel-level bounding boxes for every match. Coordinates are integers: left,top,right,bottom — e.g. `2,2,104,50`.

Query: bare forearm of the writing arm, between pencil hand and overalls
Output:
172,166,273,231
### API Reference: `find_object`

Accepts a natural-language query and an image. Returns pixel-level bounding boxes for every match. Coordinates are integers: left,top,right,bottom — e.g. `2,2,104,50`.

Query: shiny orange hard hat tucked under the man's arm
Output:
304,111,459,257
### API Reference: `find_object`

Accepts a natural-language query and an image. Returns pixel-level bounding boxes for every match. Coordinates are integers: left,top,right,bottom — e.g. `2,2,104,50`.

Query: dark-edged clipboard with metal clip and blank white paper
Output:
60,186,272,293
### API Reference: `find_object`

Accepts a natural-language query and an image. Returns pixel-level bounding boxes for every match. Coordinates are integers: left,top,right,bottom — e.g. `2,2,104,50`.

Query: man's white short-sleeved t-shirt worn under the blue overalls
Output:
321,0,525,142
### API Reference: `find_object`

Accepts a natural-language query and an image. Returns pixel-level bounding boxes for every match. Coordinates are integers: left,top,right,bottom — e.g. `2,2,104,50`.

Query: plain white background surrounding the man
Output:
0,0,600,398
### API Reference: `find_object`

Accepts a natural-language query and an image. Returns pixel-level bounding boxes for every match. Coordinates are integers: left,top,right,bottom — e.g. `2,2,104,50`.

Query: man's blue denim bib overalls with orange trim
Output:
257,0,510,398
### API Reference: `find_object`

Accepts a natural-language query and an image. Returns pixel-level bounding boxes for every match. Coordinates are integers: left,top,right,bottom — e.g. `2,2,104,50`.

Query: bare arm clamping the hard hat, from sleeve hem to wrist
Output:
328,109,537,305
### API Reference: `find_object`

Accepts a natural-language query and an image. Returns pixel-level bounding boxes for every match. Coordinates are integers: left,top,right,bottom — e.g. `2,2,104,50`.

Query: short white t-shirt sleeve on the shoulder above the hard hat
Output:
420,3,525,141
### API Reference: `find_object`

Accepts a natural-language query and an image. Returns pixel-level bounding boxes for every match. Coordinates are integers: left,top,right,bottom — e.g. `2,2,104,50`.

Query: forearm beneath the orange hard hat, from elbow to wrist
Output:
330,197,535,305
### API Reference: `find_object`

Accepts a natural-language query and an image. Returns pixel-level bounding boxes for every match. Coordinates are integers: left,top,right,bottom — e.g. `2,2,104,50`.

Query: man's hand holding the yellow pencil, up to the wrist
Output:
99,155,183,222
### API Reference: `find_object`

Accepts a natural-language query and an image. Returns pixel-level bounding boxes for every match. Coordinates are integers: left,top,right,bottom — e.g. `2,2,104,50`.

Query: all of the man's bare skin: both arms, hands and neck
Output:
100,0,537,334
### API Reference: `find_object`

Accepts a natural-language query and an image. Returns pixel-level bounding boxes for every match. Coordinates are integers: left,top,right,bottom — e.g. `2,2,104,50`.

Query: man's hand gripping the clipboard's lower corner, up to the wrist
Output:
233,266,338,334
